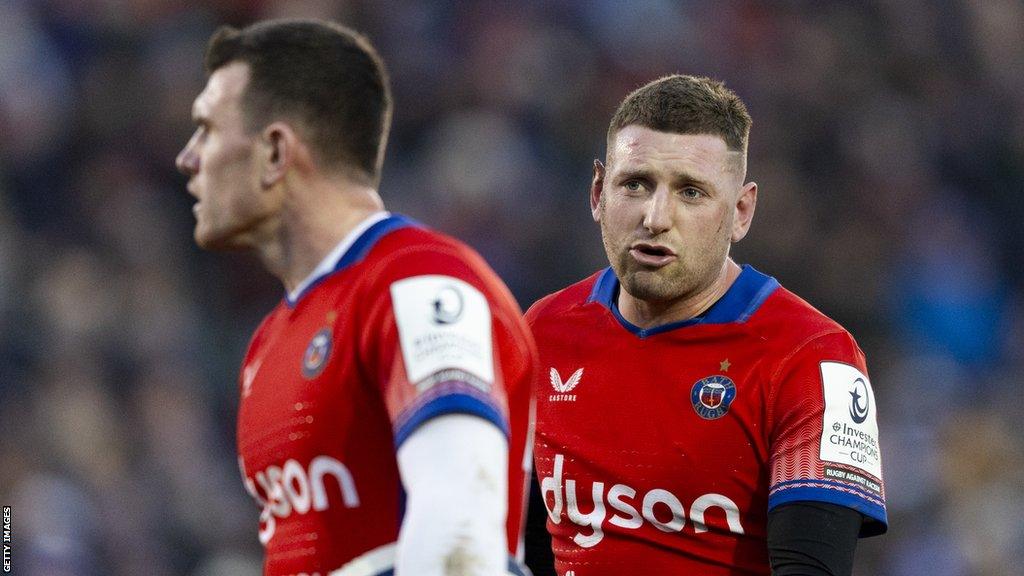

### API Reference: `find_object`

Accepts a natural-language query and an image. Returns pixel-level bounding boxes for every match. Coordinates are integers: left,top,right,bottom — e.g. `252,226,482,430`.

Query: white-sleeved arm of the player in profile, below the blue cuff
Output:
395,414,508,576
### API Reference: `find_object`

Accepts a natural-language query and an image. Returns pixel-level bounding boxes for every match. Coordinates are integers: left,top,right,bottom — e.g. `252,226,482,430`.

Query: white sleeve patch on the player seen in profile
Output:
391,275,495,385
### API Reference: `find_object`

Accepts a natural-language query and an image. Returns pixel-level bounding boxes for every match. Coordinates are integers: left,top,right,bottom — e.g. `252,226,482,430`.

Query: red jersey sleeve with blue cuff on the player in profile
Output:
364,243,515,448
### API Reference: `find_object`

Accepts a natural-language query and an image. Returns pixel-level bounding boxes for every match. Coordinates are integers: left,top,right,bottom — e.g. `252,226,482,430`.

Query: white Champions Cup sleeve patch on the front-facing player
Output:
820,362,882,479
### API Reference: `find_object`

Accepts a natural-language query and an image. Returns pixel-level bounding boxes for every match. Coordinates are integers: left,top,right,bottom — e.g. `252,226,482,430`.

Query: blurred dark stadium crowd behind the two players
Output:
0,0,1024,576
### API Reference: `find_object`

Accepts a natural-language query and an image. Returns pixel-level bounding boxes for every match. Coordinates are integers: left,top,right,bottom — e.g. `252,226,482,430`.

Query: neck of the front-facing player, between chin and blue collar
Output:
617,258,740,328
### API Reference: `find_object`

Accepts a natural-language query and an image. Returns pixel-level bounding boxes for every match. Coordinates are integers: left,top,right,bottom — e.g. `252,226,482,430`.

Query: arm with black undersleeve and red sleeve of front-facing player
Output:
767,330,887,576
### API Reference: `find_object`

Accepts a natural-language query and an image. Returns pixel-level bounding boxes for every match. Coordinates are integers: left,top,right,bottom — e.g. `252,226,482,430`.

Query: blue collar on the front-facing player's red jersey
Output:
587,264,778,338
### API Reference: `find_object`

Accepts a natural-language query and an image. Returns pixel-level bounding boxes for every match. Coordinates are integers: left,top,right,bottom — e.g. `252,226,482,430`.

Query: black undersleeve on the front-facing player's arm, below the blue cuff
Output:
768,501,863,576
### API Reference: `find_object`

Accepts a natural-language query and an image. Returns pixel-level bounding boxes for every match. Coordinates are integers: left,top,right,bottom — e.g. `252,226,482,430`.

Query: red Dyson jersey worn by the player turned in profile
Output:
238,214,537,576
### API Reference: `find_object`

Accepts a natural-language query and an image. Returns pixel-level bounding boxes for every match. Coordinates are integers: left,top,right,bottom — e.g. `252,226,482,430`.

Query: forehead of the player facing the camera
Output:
608,125,741,175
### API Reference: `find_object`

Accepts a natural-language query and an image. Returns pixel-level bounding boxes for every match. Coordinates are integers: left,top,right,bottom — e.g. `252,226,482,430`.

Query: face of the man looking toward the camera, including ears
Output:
591,125,757,303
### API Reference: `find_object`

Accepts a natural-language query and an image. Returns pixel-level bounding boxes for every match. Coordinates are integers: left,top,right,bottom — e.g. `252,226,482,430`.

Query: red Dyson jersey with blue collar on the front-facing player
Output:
526,266,887,576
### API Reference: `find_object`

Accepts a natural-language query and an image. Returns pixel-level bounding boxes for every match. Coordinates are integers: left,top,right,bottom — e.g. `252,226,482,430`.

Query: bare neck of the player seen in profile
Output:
257,174,384,292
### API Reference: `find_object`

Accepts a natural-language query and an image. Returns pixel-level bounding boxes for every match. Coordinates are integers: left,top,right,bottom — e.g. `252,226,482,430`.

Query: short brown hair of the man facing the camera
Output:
608,74,752,153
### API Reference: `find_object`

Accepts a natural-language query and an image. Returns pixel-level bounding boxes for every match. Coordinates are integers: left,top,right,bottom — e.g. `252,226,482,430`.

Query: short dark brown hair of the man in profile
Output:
205,19,391,183
